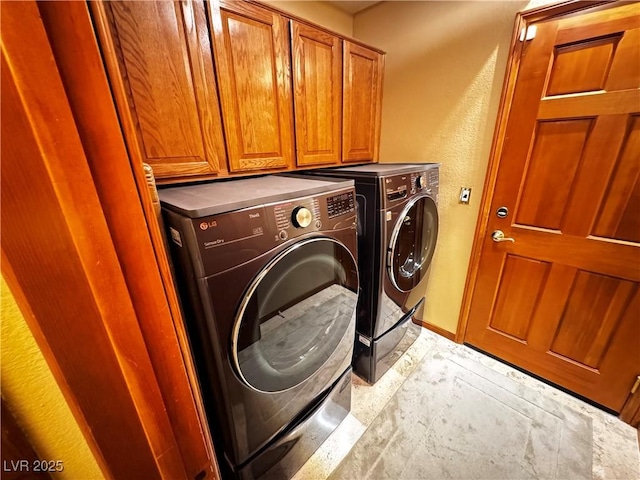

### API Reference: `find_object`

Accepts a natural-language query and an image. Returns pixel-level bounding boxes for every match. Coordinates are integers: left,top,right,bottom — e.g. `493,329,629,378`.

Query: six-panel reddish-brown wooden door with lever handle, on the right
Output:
465,3,640,411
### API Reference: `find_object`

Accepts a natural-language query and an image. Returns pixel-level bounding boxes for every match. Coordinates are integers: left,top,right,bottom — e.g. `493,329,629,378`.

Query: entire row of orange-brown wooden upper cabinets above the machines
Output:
95,0,384,183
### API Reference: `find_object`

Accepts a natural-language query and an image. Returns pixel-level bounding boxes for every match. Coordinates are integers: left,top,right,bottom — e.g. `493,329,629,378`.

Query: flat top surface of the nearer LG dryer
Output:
158,175,353,218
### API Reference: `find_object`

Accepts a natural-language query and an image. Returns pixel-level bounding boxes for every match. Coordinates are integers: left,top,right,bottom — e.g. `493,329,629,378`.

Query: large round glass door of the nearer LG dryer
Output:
231,237,358,392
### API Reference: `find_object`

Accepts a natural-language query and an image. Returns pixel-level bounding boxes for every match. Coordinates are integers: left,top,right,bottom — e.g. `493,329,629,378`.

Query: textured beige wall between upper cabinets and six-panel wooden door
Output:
353,0,549,332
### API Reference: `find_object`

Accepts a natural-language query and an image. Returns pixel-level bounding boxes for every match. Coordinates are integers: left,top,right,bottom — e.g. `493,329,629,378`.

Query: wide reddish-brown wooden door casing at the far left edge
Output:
0,2,192,479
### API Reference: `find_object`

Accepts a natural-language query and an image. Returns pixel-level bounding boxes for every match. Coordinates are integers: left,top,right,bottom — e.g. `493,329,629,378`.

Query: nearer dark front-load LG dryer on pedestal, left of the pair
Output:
159,176,359,478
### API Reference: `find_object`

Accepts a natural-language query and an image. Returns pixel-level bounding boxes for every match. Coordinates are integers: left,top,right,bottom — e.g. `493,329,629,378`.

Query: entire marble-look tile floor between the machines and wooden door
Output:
302,330,640,480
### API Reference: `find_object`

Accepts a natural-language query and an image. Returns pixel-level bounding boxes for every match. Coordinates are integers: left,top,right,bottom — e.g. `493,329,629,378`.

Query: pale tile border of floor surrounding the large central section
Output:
294,329,640,480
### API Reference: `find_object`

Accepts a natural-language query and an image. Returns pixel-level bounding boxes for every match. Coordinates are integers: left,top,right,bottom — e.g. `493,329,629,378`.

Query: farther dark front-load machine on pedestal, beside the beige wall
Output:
305,163,440,383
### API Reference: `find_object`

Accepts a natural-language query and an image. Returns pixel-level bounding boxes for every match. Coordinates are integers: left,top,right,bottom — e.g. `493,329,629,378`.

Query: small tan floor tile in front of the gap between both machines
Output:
351,369,405,427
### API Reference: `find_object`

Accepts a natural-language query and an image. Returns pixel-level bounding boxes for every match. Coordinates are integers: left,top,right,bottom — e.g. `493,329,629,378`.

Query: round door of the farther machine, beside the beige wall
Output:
387,195,438,292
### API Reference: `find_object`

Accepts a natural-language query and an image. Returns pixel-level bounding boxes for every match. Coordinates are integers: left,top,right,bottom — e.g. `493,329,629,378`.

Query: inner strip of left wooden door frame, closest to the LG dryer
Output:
43,2,217,480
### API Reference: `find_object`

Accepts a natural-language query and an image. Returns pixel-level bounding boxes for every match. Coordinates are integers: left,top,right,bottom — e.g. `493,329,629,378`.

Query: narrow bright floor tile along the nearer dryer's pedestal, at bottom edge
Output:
292,414,366,480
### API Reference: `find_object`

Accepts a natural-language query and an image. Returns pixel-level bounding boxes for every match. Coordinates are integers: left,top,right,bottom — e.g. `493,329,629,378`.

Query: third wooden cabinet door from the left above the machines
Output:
291,21,342,166
